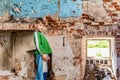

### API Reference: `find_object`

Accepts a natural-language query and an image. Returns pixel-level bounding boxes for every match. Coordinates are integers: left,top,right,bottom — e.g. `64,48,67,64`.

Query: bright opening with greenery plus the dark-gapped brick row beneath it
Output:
86,39,110,64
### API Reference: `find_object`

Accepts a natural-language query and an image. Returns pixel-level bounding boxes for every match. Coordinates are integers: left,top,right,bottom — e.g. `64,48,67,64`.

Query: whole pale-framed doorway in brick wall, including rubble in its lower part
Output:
83,37,117,80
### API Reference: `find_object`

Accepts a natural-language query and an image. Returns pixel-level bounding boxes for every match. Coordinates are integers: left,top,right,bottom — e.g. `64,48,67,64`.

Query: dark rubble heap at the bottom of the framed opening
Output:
84,64,116,80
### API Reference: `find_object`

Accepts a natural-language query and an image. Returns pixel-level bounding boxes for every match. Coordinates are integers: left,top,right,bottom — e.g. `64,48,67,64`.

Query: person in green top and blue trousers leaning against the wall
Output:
34,18,52,80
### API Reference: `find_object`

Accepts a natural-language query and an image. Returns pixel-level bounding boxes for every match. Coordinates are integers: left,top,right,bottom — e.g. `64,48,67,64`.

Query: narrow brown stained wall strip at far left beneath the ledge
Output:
0,32,13,70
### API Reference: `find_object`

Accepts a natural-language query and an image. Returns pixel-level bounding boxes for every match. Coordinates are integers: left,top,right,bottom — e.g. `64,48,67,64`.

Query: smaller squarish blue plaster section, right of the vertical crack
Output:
59,0,82,18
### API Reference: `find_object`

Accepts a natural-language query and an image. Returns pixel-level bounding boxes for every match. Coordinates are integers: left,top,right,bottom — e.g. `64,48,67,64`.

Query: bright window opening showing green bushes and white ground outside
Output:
87,40,110,59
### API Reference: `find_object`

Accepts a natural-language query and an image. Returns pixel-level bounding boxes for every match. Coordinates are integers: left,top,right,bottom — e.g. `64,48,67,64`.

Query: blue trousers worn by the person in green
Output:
36,54,47,80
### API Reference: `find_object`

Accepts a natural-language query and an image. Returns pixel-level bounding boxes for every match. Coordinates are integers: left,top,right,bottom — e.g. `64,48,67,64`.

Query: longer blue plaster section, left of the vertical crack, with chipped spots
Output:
11,0,58,18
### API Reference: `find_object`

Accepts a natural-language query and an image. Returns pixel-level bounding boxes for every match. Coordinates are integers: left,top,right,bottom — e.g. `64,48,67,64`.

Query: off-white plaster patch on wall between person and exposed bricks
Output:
48,36,80,80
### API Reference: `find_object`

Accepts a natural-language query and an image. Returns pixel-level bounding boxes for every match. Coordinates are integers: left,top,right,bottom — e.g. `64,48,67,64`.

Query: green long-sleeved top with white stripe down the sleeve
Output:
34,31,52,55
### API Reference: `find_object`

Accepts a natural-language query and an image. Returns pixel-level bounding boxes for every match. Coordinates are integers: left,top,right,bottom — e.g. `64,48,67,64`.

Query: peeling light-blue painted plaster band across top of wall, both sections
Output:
0,0,83,18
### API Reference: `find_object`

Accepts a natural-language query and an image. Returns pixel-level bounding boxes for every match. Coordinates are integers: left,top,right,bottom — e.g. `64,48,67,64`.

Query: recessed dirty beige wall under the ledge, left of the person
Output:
0,31,35,80
